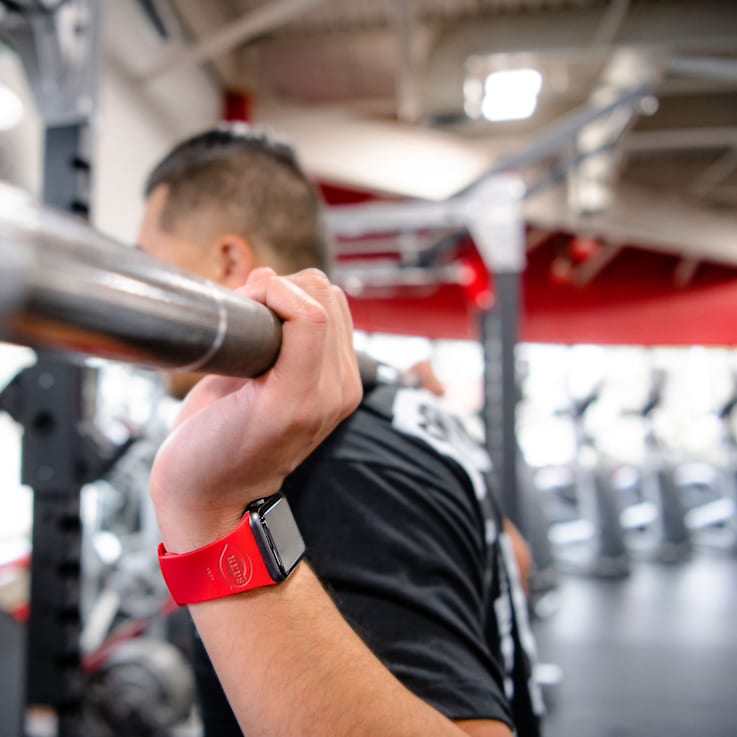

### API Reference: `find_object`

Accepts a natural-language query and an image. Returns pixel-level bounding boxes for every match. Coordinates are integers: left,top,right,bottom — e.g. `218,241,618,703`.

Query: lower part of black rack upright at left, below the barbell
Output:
15,359,90,737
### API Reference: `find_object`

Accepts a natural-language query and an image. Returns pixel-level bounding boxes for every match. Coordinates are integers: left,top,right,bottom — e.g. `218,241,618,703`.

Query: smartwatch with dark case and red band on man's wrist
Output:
158,493,305,606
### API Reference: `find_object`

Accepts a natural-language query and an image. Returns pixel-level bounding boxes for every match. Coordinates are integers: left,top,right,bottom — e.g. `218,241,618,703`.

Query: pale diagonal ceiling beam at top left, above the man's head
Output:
142,0,324,82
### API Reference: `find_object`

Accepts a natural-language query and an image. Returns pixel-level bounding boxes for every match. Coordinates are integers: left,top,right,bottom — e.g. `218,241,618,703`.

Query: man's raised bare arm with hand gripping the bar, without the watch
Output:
151,270,511,737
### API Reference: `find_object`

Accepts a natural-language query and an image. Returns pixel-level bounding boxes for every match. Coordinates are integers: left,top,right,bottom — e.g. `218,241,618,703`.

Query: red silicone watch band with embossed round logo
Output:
159,512,276,606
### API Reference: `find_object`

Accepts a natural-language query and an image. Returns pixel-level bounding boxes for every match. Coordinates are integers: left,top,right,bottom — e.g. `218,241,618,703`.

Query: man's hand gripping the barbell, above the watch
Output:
151,269,361,552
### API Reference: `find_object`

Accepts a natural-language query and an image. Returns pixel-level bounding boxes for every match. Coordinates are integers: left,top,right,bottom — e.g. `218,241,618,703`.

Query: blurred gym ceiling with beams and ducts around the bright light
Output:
141,0,737,274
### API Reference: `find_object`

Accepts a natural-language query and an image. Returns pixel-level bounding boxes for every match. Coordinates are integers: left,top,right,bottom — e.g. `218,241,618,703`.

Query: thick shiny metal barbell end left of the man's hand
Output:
0,184,281,377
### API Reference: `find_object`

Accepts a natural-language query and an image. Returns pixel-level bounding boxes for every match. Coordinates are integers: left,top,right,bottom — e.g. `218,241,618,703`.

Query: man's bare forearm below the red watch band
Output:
191,563,511,737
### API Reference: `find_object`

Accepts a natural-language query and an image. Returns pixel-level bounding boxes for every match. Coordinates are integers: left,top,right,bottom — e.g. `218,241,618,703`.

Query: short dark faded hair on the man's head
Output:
144,123,331,272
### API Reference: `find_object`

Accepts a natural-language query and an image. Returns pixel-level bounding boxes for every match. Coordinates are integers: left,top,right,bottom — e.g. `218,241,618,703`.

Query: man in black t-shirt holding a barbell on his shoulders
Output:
139,127,540,737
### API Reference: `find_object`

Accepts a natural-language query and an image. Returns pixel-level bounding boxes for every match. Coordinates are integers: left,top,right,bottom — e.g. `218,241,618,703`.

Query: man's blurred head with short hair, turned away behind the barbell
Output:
138,124,330,395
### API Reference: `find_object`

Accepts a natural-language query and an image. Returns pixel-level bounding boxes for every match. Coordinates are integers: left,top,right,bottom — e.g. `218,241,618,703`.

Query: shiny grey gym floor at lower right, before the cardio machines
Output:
535,553,737,737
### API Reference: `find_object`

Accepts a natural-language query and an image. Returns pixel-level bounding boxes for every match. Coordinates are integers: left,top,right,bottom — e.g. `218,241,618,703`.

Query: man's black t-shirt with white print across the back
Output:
196,386,541,737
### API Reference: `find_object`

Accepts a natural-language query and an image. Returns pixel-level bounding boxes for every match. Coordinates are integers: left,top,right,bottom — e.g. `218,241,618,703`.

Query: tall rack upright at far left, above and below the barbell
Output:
0,7,102,737
